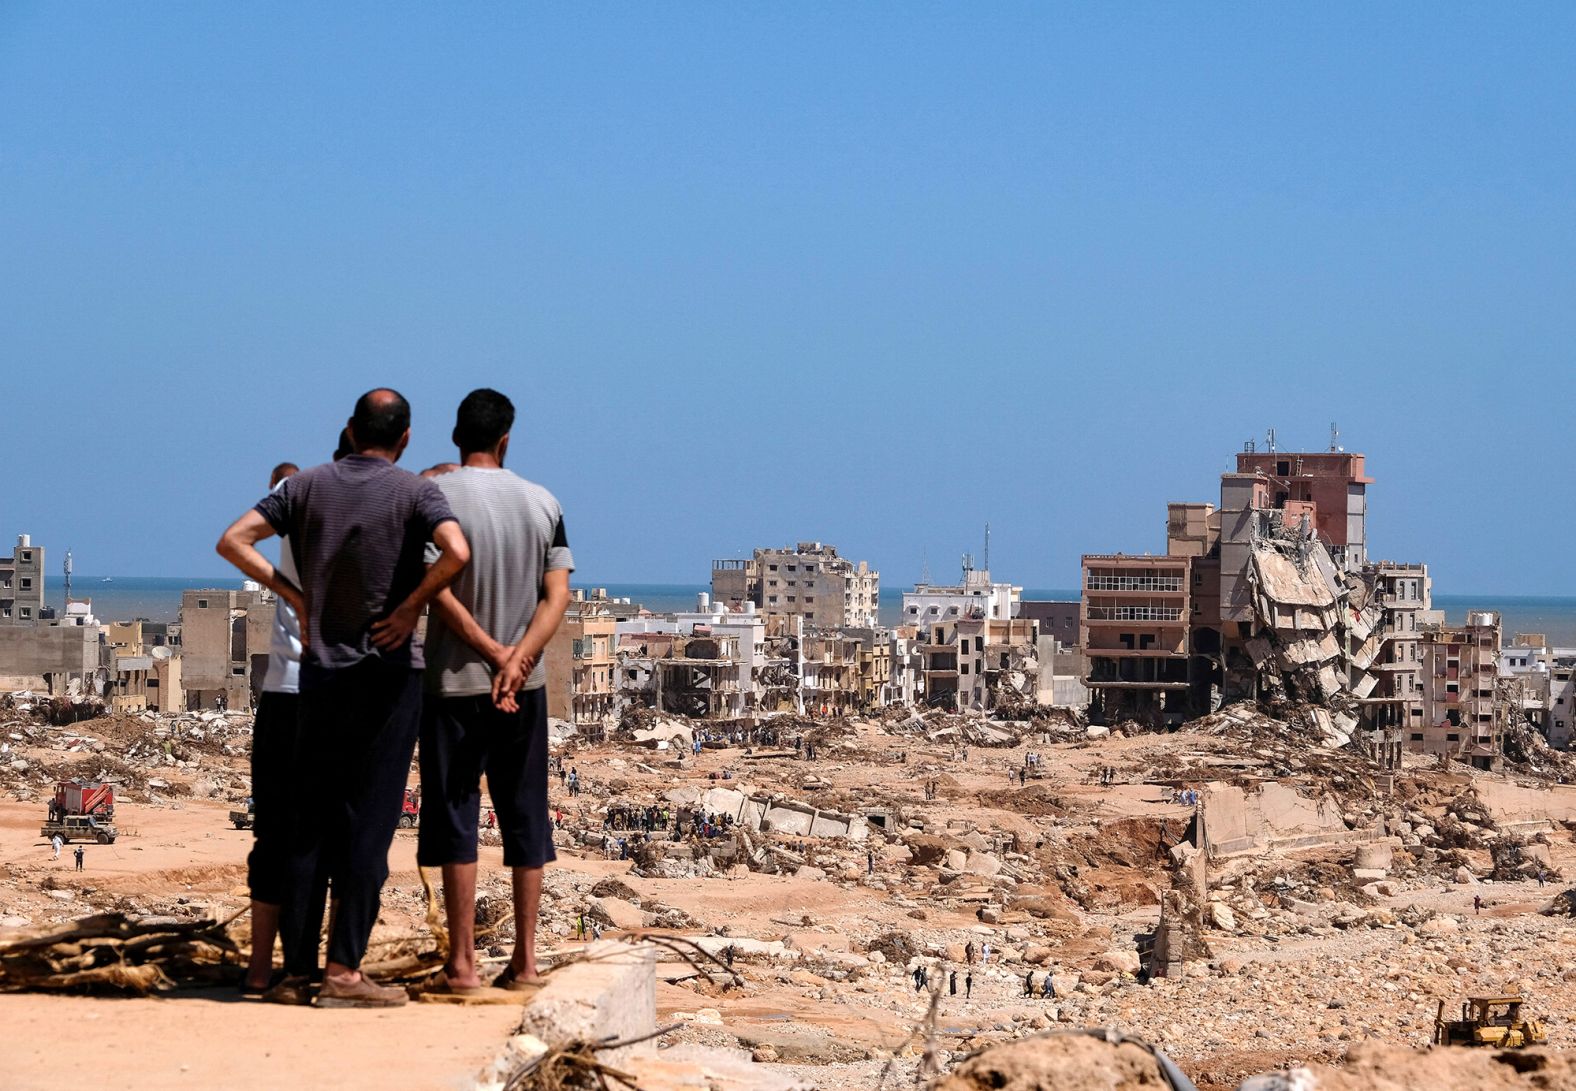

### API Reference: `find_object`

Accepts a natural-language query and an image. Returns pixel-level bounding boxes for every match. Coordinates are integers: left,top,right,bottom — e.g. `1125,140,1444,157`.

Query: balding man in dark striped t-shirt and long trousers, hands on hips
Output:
219,389,470,1007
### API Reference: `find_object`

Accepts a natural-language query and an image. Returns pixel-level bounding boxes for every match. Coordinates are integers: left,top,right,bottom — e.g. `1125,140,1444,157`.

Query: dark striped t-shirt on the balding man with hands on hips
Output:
257,454,454,691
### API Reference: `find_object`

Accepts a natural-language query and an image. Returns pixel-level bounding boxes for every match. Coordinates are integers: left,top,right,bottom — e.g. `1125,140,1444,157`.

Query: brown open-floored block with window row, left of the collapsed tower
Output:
1081,553,1193,721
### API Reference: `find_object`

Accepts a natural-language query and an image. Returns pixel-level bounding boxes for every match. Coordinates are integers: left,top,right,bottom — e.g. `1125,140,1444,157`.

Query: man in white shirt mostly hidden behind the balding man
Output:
241,462,301,996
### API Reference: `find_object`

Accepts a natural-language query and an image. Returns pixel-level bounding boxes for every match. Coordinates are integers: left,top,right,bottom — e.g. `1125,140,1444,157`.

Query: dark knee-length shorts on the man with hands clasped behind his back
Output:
416,689,558,867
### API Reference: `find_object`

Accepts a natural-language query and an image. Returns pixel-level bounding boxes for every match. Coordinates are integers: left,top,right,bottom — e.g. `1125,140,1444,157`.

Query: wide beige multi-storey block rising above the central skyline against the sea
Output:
711,542,881,629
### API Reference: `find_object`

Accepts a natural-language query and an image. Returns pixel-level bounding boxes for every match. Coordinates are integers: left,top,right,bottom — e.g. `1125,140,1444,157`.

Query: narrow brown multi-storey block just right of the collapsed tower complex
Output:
1406,610,1505,768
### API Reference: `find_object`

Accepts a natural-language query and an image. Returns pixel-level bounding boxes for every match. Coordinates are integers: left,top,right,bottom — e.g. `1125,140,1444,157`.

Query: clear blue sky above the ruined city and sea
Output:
0,2,1576,594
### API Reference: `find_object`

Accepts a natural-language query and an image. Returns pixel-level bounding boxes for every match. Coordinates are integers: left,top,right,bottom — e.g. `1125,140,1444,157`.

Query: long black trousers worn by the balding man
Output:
279,657,421,974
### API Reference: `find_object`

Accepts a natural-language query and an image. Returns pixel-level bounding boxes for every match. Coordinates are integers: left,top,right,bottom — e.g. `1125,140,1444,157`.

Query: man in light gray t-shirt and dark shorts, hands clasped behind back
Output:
416,389,574,992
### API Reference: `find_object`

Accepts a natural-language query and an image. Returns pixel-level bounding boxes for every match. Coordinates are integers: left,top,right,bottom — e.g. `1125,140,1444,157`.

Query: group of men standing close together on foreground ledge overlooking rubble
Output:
217,388,578,1007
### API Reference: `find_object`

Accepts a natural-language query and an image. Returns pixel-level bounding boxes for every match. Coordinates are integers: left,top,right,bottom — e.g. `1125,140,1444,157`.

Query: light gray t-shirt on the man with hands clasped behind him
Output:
426,467,575,697
